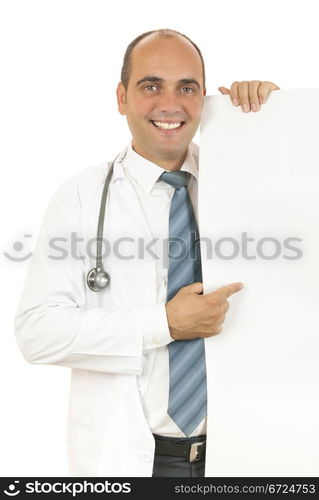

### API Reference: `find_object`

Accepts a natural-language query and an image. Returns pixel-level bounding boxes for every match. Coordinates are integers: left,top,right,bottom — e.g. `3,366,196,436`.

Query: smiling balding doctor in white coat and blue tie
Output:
15,30,278,477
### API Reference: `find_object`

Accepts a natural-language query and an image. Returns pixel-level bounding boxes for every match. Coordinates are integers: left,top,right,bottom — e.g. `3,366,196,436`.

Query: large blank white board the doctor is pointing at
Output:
198,89,319,477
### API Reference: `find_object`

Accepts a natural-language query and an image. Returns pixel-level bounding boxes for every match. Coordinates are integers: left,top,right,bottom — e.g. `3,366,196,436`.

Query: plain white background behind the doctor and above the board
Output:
0,0,319,476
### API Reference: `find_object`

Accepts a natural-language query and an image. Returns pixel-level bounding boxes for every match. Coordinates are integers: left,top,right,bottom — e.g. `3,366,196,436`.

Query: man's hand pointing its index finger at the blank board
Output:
166,282,243,340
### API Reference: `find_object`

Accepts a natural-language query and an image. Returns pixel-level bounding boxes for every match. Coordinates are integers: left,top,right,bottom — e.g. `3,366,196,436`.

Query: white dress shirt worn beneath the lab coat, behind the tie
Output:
123,142,207,437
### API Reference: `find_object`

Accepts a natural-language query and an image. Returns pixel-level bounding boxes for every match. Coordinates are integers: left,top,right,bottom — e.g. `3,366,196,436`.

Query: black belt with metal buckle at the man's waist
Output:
153,434,206,462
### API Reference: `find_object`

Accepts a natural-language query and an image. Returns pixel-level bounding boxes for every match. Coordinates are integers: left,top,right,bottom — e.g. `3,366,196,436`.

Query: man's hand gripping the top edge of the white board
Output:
218,80,280,113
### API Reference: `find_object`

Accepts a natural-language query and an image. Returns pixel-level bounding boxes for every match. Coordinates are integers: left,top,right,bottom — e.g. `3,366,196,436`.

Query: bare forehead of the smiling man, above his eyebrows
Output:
131,35,202,81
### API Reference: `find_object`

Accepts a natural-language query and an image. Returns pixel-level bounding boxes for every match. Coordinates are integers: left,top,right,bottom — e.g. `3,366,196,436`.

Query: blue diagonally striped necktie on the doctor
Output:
160,170,207,436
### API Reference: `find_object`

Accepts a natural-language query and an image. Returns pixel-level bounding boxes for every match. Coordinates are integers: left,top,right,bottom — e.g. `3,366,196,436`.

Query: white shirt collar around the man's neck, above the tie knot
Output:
123,141,198,194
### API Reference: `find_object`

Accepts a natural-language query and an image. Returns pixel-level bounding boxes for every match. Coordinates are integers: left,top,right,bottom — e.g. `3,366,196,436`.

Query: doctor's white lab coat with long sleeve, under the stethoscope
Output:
15,149,172,477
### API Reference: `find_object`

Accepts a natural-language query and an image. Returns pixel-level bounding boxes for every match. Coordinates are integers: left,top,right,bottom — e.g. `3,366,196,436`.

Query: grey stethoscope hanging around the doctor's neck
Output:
86,157,121,292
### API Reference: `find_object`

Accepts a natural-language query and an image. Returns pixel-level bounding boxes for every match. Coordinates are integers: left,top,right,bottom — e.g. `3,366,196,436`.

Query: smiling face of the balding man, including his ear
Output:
117,35,206,167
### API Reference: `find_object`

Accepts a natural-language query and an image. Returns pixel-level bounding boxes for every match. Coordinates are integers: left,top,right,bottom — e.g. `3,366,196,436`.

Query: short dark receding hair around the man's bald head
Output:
121,28,205,90
